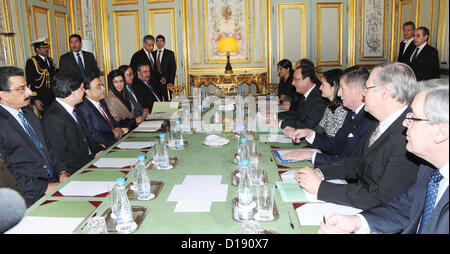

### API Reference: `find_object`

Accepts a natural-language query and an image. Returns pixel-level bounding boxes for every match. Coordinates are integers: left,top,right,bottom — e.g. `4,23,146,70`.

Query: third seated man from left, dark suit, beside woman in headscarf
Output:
77,77,123,149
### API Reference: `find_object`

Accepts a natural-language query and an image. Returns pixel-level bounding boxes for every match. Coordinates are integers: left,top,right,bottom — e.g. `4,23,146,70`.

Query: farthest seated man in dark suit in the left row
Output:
131,64,163,113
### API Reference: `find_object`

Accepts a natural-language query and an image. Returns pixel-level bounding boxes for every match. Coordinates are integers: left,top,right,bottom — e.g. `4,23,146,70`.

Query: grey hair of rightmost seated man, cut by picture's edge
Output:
423,79,449,124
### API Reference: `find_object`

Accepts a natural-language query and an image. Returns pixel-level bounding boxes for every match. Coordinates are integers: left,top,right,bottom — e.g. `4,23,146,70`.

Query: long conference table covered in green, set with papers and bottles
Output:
21,105,318,234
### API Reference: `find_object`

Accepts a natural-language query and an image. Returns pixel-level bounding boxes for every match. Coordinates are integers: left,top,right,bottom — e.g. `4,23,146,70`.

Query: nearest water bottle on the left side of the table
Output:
116,178,137,234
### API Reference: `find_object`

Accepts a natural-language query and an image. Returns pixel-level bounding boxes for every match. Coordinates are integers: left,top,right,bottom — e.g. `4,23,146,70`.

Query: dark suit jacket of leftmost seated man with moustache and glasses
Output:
0,106,66,204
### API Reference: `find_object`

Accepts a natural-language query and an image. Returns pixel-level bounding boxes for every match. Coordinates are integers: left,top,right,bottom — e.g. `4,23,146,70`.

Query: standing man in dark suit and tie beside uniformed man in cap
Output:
59,34,100,80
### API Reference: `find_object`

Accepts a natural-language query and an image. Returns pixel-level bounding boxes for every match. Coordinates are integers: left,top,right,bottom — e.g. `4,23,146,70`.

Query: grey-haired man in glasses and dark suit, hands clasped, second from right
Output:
296,63,418,209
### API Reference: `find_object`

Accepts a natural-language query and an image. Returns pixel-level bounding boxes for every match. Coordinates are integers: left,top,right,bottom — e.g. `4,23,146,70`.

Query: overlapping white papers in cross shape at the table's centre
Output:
167,175,228,212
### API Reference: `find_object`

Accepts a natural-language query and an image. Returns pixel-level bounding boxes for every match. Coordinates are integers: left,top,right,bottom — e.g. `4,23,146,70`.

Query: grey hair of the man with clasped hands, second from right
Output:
374,62,419,104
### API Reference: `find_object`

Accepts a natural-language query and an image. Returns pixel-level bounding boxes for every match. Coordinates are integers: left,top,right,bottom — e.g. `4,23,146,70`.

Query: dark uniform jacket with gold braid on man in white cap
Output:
25,55,56,112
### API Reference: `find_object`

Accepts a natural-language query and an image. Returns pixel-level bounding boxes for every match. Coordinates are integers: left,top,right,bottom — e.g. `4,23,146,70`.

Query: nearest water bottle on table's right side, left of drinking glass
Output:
238,159,253,220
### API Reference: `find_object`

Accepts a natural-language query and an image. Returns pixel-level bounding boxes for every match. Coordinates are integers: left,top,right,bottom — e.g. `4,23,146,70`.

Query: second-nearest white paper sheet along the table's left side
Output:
59,181,114,197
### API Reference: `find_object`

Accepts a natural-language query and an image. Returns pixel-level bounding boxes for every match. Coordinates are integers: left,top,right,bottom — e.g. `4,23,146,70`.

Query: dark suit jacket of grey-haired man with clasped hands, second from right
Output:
317,108,418,210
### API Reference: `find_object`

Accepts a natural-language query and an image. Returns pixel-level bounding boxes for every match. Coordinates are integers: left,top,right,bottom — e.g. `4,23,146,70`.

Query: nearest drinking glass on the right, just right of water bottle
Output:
255,183,275,221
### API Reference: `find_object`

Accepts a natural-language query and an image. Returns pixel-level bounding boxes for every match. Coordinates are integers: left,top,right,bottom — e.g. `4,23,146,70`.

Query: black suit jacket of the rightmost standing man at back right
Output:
406,44,441,81
